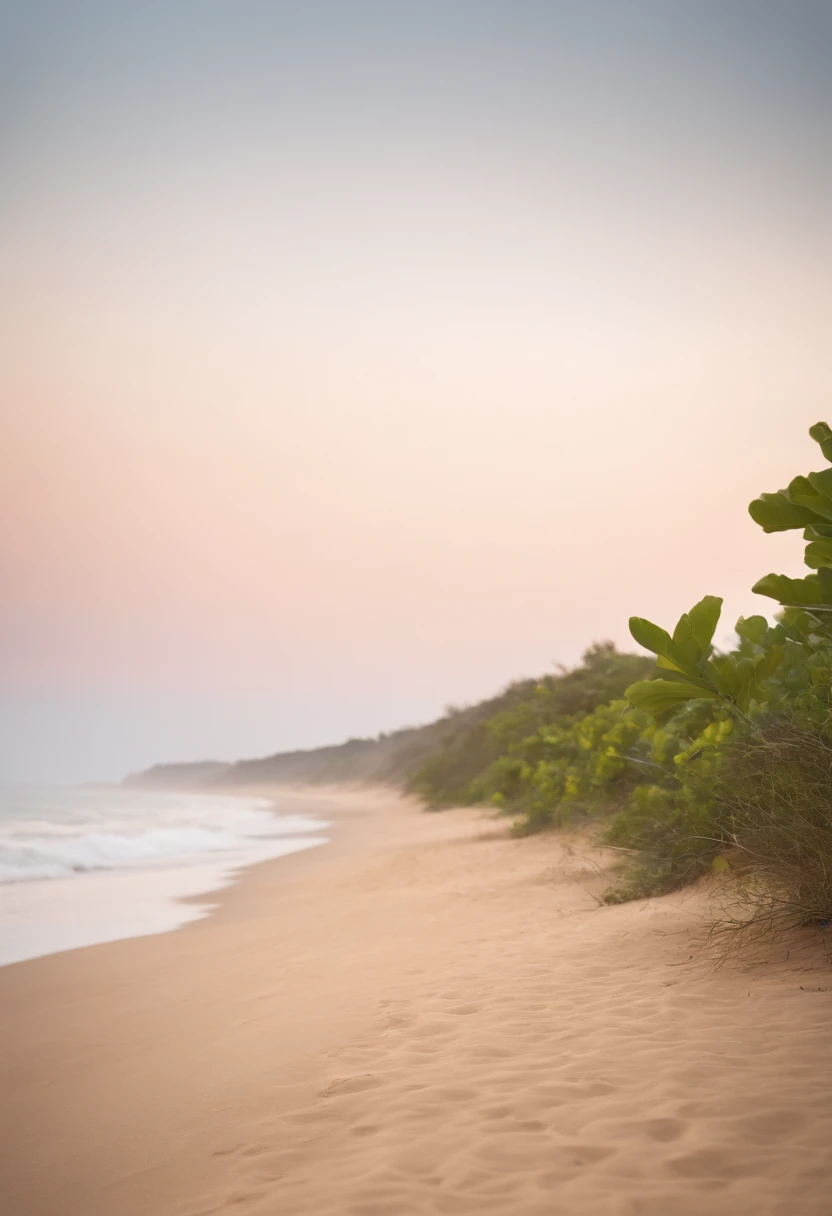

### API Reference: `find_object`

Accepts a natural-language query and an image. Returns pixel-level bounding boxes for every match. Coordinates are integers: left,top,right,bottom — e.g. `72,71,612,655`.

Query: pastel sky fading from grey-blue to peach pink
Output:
0,0,832,782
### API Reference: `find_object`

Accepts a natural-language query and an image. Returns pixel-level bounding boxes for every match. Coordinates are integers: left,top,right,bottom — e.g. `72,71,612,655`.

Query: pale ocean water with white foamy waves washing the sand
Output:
0,788,328,966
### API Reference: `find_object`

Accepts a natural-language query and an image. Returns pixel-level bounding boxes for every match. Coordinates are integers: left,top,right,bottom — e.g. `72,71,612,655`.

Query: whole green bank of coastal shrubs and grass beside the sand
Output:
409,423,832,934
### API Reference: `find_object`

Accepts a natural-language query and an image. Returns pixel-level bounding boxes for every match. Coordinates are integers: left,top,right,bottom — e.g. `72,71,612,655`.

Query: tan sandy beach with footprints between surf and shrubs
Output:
0,790,832,1216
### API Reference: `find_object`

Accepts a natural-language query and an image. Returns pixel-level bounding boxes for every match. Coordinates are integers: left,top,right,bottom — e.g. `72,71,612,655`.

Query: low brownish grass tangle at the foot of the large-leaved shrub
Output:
606,722,832,953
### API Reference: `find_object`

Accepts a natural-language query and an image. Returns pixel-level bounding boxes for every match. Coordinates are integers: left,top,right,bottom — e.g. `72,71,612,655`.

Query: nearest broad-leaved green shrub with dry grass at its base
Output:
607,423,832,914
